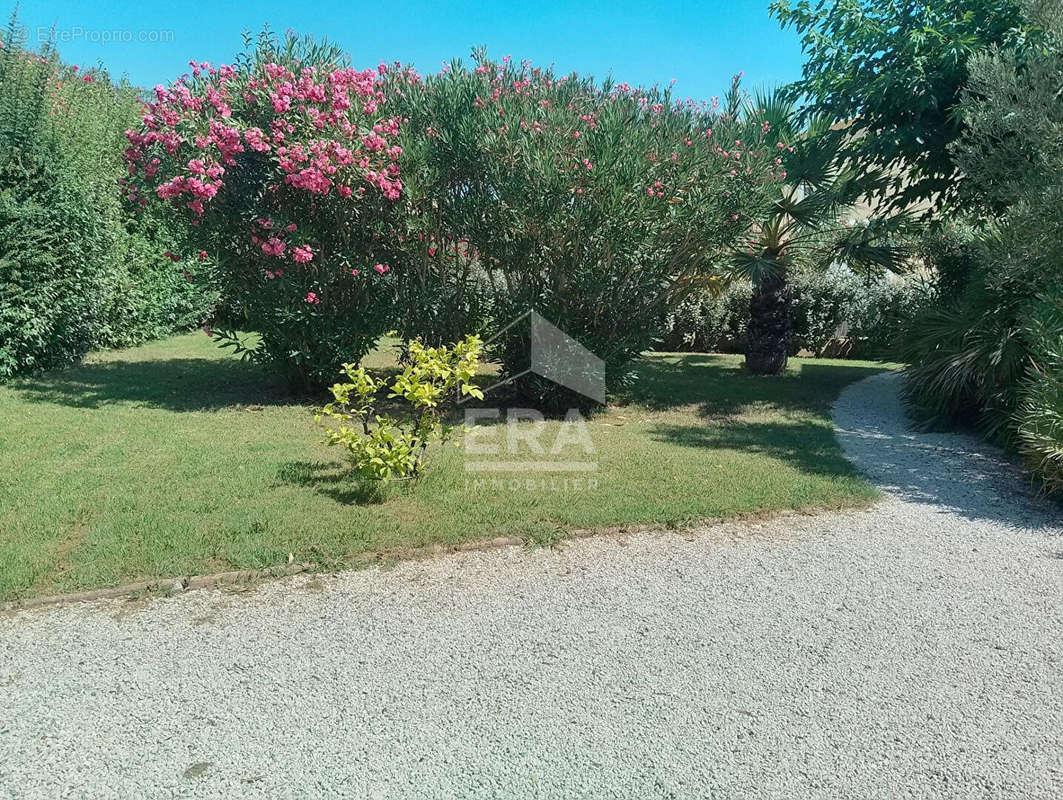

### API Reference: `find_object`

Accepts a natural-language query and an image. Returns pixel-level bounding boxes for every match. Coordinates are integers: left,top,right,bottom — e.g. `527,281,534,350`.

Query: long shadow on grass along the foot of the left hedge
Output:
9,358,301,411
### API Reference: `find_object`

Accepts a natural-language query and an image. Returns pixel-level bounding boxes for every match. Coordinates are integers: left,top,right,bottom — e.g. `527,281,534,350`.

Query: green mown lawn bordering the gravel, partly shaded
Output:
0,335,885,599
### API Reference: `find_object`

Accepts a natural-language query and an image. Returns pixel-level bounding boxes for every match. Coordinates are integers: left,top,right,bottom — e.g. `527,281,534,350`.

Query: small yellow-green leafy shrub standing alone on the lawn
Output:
315,335,484,480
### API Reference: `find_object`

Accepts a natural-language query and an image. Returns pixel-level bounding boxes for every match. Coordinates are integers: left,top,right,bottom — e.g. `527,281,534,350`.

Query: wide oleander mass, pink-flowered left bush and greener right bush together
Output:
124,34,783,394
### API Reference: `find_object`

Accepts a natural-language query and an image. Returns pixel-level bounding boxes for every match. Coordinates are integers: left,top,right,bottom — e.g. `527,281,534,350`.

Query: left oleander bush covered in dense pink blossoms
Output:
124,32,403,388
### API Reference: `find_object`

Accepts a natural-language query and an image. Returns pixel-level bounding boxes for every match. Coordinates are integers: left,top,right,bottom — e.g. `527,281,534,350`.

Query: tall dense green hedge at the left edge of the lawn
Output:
0,20,212,379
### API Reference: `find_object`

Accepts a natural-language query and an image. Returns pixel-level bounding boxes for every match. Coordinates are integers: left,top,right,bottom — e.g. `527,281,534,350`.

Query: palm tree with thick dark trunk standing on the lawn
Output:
728,98,911,375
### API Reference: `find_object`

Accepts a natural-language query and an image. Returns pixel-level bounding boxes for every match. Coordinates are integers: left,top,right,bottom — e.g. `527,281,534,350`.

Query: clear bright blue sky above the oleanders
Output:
10,0,802,100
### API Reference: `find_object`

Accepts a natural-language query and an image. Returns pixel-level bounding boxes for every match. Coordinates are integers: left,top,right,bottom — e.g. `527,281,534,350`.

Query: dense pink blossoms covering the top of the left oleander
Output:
123,54,403,218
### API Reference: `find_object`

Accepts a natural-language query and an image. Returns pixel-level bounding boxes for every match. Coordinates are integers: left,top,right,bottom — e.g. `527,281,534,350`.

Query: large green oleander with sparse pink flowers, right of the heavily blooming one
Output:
389,52,777,403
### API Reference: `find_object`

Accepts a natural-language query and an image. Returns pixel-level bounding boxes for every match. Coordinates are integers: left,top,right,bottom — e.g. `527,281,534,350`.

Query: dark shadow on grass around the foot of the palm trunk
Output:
617,353,882,416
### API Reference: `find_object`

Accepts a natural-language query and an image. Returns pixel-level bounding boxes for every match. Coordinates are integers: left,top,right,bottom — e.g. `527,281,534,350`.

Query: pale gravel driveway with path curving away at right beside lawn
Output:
0,375,1063,800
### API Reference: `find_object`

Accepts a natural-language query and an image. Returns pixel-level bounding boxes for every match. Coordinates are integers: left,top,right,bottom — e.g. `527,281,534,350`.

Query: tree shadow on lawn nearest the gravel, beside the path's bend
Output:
653,422,861,478
